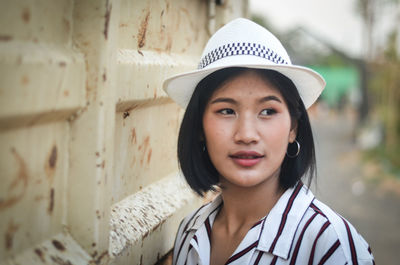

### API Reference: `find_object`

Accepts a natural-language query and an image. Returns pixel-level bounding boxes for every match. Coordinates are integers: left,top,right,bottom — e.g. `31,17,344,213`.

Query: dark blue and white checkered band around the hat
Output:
198,42,288,69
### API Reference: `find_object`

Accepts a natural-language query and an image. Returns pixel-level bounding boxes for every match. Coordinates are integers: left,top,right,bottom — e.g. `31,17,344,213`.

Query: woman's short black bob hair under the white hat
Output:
178,67,316,196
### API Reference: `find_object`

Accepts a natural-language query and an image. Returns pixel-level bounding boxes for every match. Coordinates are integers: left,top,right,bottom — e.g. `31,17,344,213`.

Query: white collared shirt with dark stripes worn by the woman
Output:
173,183,375,265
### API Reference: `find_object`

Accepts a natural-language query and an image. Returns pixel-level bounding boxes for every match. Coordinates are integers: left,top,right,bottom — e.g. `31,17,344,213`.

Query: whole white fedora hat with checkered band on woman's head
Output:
163,18,325,108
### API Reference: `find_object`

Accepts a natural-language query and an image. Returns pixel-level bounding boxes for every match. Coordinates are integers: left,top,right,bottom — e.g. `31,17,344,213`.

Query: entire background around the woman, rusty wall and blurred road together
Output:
0,0,400,265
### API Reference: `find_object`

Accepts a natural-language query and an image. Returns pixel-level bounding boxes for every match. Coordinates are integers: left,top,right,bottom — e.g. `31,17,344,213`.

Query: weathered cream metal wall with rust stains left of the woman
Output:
0,0,247,264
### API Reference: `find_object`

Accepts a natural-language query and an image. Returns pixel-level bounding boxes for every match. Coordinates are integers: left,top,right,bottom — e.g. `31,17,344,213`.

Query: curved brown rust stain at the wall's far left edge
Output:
0,148,28,211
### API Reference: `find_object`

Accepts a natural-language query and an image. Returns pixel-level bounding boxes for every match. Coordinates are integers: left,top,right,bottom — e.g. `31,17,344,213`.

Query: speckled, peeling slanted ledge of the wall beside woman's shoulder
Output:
109,172,200,264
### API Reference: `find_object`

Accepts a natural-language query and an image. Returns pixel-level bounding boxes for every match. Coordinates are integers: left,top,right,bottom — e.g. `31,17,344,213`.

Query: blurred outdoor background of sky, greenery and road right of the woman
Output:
249,0,400,264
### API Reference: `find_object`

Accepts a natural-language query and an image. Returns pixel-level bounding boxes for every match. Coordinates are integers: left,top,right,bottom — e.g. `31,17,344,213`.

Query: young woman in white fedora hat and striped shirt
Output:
164,19,374,265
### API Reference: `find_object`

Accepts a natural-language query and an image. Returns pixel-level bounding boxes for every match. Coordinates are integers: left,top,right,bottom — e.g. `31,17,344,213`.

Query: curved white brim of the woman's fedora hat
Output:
163,60,326,109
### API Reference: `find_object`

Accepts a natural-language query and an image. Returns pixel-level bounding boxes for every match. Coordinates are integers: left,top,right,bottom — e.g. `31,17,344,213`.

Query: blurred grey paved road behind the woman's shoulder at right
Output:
312,113,400,265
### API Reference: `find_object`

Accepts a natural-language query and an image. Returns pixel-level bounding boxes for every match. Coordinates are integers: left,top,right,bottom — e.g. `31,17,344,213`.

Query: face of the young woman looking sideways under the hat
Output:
203,71,296,188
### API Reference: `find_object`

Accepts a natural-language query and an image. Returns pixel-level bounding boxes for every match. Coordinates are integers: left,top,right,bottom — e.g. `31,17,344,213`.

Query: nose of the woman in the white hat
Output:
234,116,260,144
